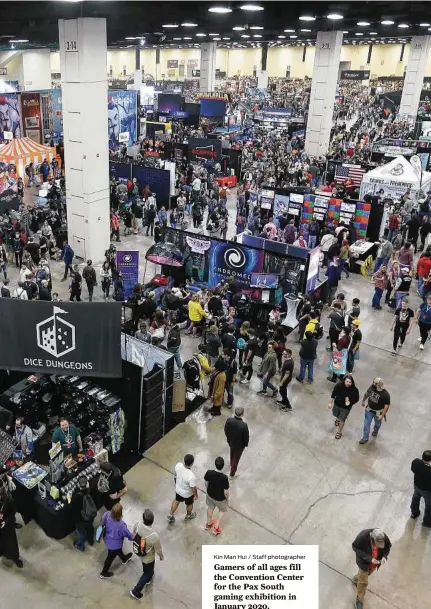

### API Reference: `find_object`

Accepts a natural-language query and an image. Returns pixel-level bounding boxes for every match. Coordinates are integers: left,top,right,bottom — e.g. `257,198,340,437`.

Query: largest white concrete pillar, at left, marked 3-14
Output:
59,18,110,262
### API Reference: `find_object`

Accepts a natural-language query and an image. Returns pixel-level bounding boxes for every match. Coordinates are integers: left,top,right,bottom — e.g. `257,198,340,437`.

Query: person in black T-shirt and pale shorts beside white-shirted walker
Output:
204,457,229,535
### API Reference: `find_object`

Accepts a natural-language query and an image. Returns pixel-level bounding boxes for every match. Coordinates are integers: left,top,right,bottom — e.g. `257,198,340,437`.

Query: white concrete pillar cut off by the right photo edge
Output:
399,36,431,118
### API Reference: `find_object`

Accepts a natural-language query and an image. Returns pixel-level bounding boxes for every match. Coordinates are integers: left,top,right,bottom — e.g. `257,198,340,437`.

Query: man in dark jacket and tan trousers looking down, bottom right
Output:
352,529,392,609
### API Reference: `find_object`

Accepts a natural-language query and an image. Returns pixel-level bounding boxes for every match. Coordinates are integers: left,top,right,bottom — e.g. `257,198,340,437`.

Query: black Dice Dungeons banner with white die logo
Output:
0,298,121,377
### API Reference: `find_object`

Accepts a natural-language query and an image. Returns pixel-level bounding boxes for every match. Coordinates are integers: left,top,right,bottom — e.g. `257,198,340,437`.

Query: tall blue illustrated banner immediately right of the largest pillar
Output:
108,90,138,150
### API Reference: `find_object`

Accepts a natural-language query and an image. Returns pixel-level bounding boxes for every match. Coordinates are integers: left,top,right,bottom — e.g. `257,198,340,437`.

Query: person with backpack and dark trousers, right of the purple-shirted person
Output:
130,510,165,600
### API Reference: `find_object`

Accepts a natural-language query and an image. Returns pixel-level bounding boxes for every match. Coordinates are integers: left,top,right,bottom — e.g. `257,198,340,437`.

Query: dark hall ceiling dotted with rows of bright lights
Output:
0,0,431,50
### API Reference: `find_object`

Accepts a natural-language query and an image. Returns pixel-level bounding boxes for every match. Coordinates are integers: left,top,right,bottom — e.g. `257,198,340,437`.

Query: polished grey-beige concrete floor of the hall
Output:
0,191,431,609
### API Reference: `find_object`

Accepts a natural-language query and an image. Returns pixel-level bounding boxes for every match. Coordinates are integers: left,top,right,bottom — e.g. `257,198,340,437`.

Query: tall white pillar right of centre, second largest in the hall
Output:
305,32,343,156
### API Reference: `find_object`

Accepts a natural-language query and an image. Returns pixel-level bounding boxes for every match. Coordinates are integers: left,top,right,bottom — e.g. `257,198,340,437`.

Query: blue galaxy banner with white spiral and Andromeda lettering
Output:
208,241,264,288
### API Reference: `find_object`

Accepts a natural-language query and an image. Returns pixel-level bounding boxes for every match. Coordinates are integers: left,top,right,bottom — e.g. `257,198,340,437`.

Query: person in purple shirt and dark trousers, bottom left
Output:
100,503,133,579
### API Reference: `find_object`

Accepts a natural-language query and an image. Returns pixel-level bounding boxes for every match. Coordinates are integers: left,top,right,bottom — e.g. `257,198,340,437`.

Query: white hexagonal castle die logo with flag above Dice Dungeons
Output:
36,307,76,358
